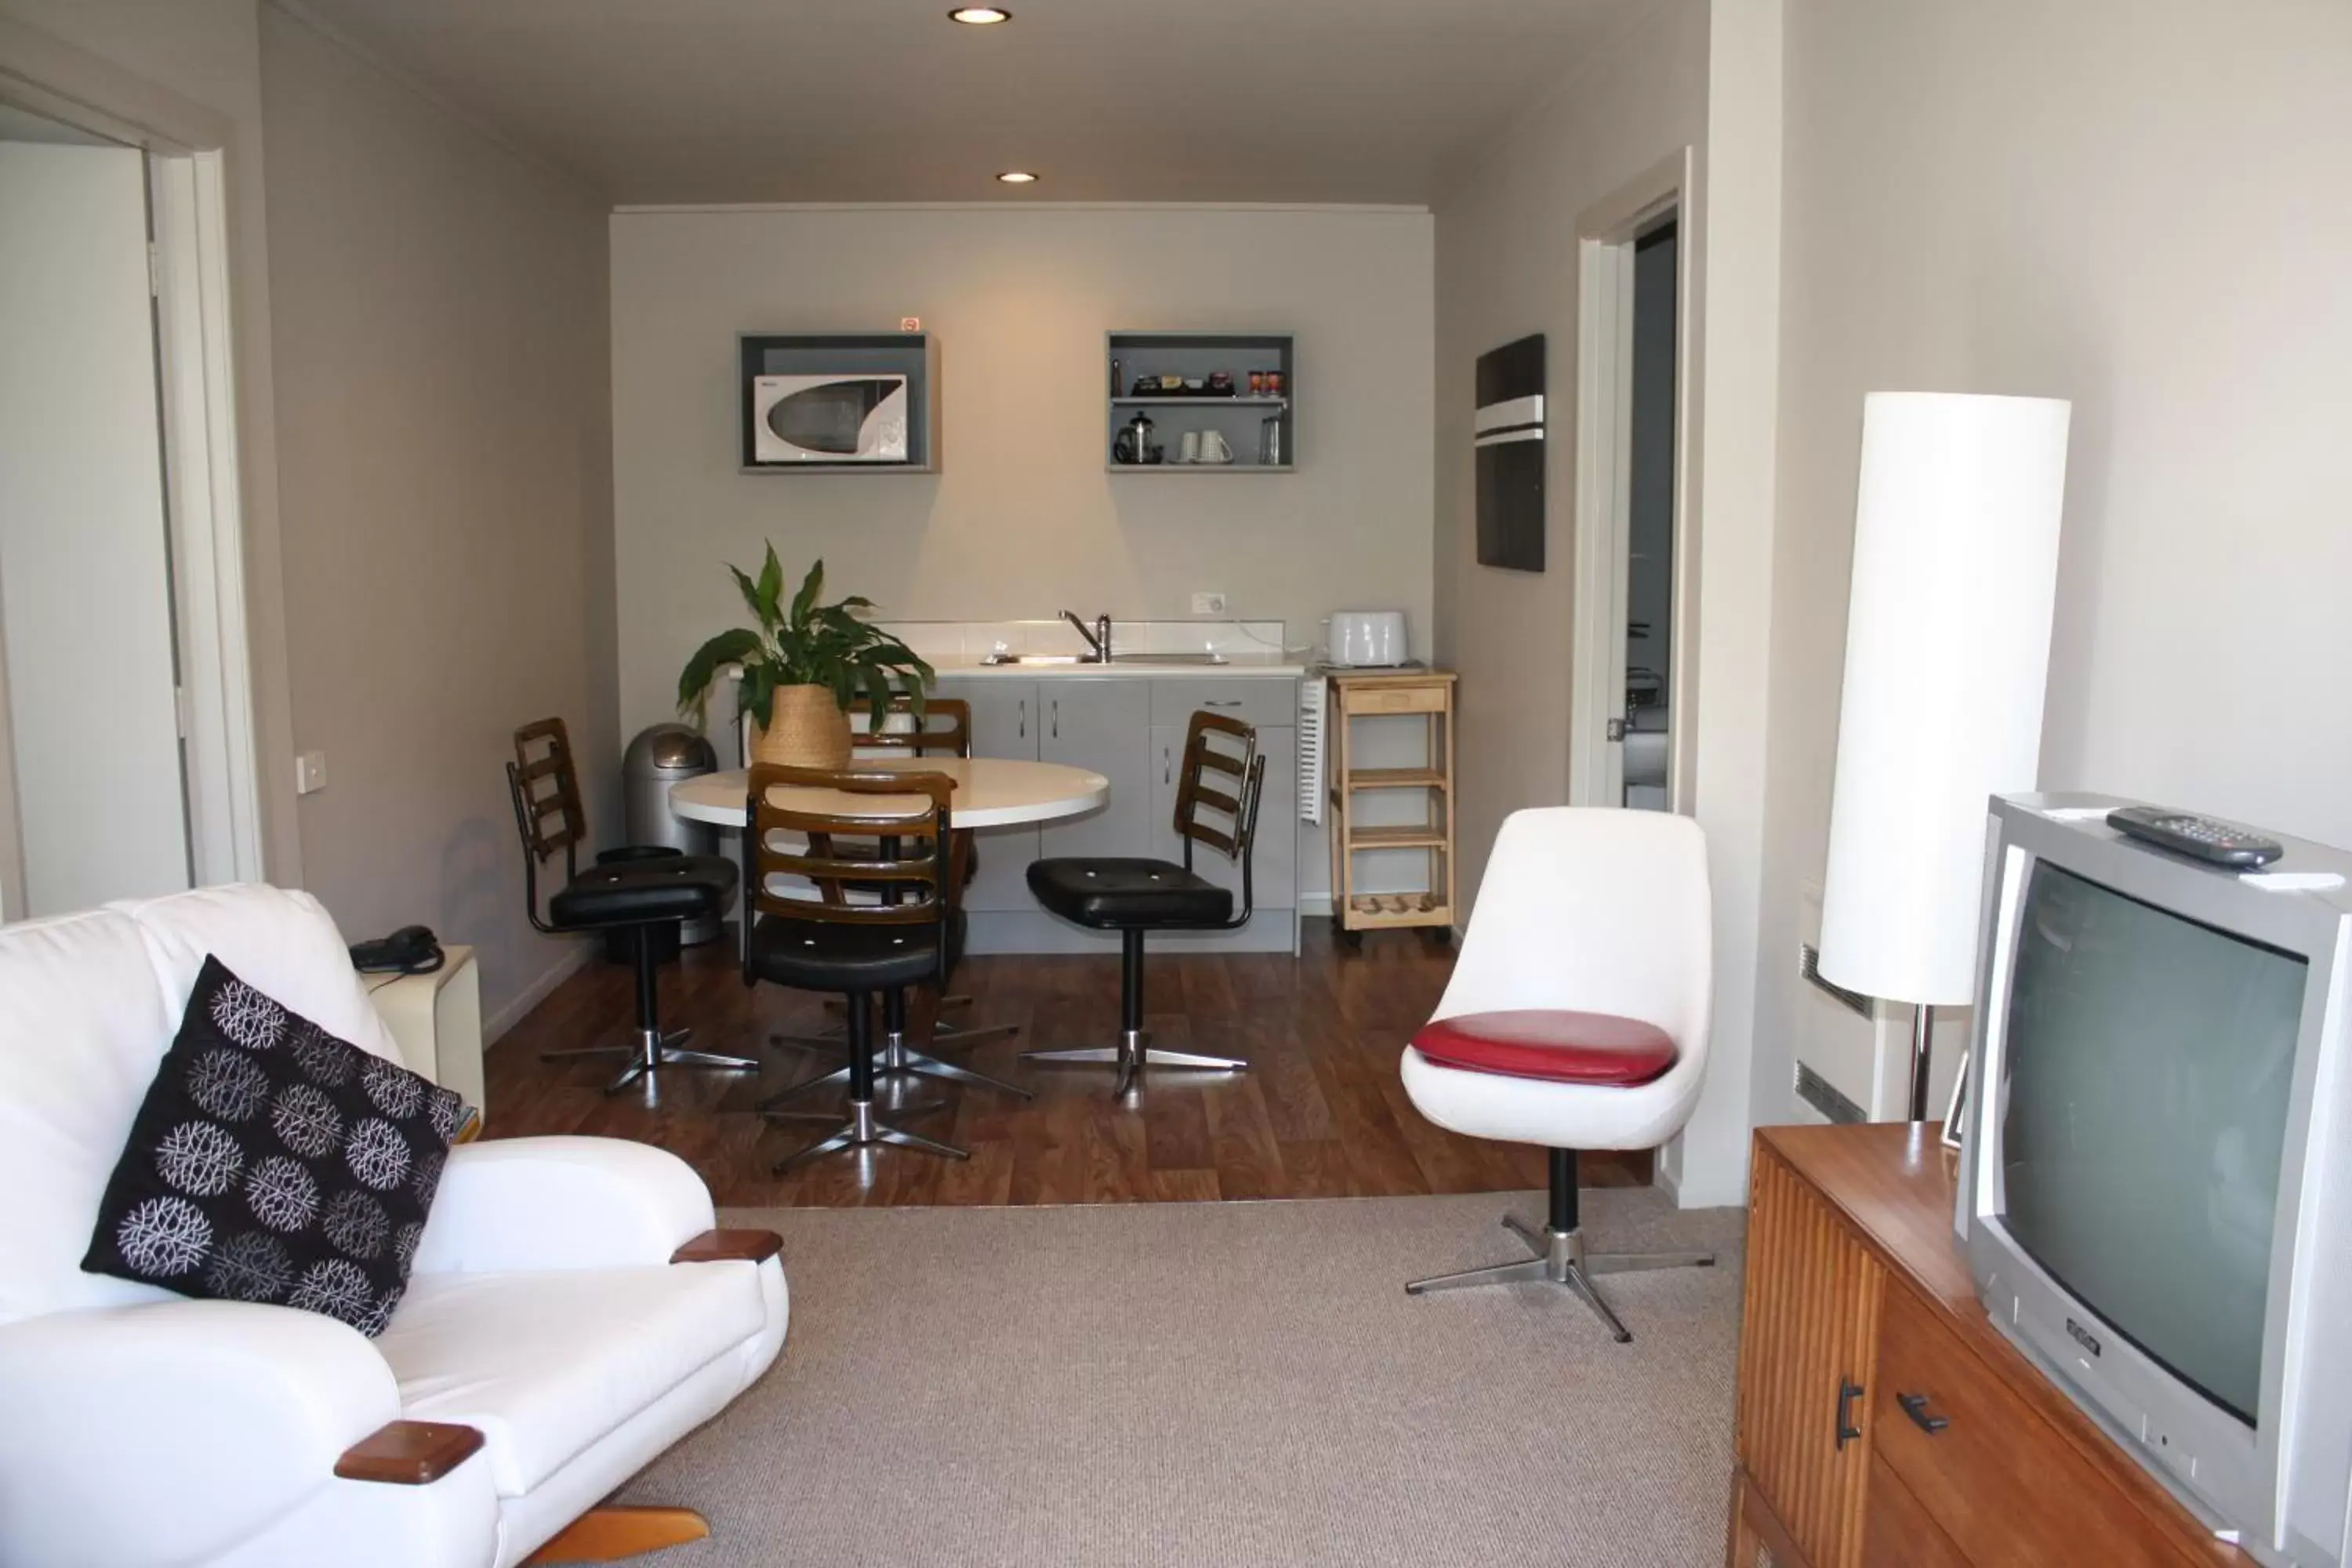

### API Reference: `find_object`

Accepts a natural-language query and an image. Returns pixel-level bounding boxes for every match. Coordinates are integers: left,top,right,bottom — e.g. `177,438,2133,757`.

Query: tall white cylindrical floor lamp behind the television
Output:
1820,393,2072,1121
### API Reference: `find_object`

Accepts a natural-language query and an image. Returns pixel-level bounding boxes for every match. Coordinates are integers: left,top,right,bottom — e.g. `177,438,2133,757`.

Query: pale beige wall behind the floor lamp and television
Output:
1755,0,2352,1121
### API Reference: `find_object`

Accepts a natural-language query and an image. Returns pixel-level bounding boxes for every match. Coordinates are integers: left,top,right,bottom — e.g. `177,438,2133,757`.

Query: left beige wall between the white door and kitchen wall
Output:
261,9,619,1020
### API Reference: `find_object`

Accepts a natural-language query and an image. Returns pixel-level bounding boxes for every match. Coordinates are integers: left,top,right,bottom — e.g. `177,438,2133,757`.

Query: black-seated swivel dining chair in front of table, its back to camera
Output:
743,764,969,1173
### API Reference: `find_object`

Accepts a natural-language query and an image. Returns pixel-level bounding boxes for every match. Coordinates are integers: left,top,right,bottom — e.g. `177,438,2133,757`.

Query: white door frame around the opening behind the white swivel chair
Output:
1569,148,1698,815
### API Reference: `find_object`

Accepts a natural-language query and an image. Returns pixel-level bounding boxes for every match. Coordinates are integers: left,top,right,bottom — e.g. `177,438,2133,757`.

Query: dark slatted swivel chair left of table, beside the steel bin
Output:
506,720,760,1093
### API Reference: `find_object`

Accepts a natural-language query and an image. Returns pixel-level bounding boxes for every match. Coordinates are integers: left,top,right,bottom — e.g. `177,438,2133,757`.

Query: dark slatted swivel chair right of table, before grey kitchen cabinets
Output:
1021,713,1265,1095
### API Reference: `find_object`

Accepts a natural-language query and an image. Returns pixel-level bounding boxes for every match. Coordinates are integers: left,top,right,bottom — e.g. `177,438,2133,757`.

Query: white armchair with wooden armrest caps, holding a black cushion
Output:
0,886,786,1568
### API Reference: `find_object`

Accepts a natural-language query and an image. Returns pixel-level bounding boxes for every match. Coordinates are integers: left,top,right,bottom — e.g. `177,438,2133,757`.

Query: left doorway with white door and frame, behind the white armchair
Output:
0,101,261,919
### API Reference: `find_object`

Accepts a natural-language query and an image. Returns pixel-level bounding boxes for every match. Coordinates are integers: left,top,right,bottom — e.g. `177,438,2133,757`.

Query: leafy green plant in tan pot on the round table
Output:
677,546,936,769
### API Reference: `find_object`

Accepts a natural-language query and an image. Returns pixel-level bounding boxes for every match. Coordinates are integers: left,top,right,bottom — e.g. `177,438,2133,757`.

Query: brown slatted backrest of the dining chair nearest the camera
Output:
743,764,962,926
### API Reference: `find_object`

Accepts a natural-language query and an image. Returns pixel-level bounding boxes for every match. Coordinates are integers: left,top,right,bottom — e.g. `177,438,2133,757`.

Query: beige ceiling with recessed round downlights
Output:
280,0,1642,205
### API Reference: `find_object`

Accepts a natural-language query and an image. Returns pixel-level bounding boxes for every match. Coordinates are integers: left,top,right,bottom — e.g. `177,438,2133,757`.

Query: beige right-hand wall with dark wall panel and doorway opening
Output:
1435,0,1780,1203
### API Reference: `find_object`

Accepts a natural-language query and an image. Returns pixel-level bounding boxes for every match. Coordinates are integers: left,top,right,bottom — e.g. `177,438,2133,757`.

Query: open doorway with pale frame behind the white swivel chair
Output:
1569,151,1698,813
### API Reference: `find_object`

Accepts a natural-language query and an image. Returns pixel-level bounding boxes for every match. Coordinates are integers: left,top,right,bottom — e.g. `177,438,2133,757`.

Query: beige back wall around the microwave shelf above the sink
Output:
612,207,1430,734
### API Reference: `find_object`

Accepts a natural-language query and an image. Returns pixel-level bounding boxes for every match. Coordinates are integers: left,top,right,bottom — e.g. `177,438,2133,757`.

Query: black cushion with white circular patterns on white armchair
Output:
82,956,466,1338
